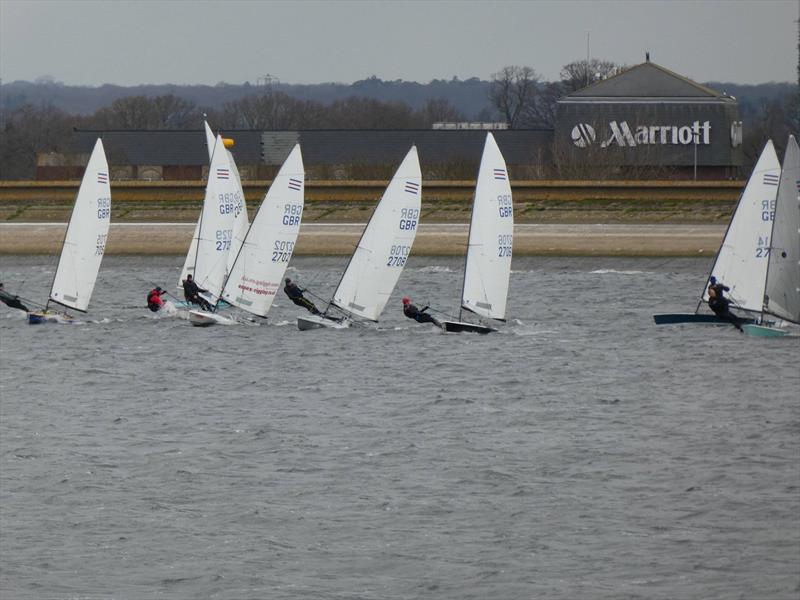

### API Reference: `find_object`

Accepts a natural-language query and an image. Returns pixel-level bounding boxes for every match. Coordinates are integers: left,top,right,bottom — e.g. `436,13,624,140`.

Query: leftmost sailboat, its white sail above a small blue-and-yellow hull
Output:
28,139,111,325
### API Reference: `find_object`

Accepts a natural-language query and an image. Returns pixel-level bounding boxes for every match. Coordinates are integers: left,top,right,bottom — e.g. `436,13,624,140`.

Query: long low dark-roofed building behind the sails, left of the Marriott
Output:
48,129,553,181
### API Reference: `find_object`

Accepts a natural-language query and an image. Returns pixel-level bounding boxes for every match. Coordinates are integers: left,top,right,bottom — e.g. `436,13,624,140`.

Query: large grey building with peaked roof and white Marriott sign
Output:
553,60,743,179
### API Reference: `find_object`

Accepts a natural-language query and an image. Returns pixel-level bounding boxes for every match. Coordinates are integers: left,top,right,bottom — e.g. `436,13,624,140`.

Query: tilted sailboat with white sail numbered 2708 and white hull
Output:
297,146,422,330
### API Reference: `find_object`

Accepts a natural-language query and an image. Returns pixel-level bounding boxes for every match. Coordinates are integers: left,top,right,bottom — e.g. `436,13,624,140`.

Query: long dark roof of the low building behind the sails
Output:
73,129,553,166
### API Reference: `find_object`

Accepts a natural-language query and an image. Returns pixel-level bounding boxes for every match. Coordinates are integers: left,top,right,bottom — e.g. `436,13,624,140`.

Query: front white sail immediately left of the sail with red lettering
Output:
194,136,241,300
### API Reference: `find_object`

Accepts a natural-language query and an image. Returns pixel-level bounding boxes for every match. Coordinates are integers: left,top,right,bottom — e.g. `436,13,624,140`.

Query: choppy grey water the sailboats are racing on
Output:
0,257,800,600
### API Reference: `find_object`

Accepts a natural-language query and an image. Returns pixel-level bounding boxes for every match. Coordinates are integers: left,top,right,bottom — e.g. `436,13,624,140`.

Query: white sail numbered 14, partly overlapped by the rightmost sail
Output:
703,140,781,311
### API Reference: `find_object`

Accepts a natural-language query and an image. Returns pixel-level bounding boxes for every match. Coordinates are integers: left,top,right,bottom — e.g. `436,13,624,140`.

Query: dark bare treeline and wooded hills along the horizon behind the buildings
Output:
0,59,800,179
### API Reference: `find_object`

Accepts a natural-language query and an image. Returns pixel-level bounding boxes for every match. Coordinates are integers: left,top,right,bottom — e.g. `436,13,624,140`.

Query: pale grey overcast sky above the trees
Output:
0,0,799,85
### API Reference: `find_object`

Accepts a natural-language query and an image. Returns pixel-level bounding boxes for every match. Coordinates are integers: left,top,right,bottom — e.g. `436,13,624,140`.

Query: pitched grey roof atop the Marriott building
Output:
560,61,733,102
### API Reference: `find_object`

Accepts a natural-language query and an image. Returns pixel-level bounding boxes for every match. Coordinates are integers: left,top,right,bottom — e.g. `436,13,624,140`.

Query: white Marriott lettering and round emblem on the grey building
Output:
571,121,711,148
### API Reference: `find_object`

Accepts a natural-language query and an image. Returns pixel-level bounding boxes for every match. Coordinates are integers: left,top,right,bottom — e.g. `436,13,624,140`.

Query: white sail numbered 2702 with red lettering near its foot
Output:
222,145,305,317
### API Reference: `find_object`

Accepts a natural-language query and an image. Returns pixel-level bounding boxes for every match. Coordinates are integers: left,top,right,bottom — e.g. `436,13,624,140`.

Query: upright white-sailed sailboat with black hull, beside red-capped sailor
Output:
442,133,514,333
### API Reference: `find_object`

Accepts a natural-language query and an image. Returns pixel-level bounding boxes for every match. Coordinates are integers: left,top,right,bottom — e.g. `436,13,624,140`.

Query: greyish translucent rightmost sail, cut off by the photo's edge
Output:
764,136,800,323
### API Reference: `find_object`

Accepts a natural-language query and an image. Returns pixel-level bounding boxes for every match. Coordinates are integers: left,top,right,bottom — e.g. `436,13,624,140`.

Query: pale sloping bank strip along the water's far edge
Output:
0,223,725,257
